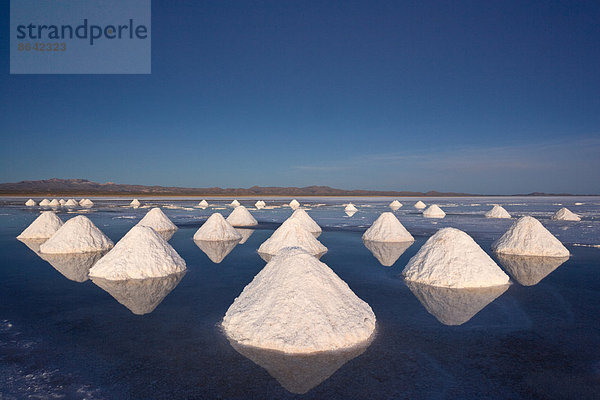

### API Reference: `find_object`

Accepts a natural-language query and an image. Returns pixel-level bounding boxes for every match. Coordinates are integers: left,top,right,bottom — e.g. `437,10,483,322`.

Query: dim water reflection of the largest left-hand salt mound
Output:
92,271,185,315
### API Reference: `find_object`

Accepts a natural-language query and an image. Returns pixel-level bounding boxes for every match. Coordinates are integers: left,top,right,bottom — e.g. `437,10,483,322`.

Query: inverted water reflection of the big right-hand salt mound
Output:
405,281,510,325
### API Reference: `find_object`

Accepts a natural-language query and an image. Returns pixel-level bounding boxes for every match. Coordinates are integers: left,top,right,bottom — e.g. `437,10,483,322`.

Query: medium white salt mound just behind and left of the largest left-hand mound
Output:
40,215,113,254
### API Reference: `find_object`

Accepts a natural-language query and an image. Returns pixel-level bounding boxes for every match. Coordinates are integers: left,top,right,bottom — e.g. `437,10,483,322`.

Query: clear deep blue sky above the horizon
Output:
0,0,600,193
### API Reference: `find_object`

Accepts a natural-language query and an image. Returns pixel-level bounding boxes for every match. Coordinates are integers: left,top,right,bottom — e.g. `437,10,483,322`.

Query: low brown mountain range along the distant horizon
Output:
0,178,570,197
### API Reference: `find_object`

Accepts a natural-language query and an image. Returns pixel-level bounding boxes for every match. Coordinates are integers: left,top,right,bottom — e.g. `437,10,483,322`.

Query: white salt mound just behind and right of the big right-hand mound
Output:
492,216,570,257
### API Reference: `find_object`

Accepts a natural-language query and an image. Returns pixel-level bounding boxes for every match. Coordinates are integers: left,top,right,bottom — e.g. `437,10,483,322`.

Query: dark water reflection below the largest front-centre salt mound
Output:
229,334,372,394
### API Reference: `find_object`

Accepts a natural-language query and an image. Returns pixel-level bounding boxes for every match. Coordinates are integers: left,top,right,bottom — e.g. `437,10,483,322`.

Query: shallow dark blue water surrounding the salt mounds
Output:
0,198,600,399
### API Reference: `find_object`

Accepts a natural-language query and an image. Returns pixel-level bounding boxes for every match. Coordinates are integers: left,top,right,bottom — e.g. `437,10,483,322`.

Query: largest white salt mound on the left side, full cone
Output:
90,225,186,281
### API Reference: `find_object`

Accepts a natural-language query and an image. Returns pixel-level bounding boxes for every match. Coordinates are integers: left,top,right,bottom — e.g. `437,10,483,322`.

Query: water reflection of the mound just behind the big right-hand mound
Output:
496,253,569,286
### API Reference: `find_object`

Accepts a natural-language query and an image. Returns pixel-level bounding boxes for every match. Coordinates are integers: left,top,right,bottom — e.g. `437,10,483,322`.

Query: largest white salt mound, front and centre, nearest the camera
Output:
223,248,375,353
